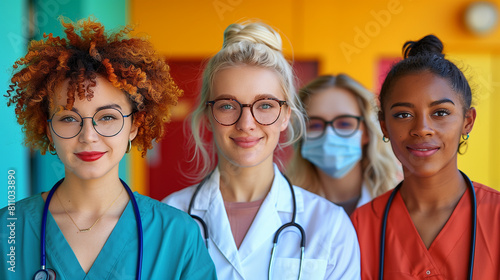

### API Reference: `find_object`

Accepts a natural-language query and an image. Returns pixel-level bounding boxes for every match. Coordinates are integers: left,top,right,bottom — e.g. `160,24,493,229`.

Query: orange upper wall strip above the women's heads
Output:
131,0,500,88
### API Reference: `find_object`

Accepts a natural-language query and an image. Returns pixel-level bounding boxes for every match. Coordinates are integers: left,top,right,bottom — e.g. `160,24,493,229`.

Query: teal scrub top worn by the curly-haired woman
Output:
0,193,217,280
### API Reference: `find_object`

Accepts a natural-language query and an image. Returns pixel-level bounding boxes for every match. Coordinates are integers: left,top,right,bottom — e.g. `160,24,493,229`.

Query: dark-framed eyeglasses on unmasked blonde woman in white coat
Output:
206,98,286,126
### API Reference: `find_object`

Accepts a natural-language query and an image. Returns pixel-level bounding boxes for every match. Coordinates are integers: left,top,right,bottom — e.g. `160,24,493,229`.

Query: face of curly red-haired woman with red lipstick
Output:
48,76,137,180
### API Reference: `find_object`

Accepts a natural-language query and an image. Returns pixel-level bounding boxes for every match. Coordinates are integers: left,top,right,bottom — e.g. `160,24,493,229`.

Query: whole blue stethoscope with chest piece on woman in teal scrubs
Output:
33,178,143,280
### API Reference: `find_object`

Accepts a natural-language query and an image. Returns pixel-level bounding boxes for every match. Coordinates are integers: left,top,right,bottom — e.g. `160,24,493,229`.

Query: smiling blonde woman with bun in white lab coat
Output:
163,22,360,280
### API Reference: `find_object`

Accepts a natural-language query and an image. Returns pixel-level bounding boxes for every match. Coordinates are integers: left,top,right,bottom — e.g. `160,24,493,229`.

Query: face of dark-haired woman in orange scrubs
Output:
380,72,476,177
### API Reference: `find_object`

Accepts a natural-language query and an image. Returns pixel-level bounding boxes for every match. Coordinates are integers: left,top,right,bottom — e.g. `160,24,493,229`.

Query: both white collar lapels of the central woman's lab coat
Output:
188,165,304,278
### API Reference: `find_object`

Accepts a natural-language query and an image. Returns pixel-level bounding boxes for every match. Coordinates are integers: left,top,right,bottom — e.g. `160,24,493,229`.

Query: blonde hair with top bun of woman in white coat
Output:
190,22,305,180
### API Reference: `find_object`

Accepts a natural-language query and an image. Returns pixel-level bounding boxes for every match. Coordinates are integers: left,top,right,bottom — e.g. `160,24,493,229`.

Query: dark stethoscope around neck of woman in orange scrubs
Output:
378,171,477,280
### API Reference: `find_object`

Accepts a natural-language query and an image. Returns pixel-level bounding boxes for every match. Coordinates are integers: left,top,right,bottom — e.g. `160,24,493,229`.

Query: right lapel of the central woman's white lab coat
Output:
239,165,293,262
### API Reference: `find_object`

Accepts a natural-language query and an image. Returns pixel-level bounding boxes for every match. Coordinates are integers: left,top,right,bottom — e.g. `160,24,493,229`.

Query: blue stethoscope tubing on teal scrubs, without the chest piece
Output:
35,178,144,280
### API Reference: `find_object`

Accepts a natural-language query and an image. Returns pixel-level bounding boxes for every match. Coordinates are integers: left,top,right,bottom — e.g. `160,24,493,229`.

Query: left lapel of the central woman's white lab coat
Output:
194,168,243,278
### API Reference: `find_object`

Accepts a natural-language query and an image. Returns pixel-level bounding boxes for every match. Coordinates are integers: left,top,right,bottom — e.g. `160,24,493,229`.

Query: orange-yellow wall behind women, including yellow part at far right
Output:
131,0,500,189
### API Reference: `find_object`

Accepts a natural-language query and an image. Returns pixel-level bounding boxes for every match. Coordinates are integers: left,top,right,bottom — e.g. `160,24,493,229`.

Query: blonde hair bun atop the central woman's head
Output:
222,22,282,52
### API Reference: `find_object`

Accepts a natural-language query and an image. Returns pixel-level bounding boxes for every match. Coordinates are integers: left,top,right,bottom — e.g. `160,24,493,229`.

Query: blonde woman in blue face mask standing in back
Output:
287,74,398,215
